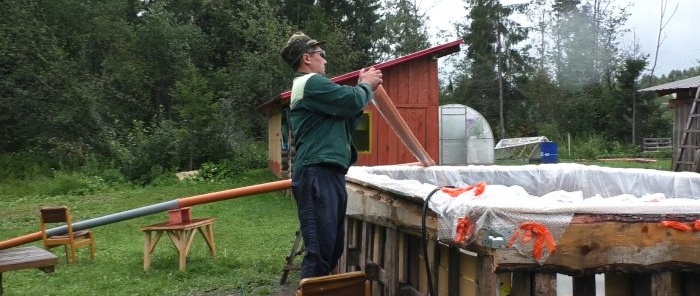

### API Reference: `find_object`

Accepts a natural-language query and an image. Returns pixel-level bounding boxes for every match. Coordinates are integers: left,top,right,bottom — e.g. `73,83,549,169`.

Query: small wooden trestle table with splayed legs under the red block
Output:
141,218,216,271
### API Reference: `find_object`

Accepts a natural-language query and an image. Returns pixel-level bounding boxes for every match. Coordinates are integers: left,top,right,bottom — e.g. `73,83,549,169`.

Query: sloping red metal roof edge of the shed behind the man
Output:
258,39,464,110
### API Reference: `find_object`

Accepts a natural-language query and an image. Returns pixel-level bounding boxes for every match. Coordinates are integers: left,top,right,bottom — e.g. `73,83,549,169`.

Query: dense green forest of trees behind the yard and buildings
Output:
0,0,700,184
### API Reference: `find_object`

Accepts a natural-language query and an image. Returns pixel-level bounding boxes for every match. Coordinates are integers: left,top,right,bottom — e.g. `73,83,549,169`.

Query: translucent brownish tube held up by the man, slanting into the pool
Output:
372,84,435,167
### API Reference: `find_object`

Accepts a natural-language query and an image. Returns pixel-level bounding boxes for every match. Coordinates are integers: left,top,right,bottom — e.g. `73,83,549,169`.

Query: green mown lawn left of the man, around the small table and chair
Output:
0,170,298,296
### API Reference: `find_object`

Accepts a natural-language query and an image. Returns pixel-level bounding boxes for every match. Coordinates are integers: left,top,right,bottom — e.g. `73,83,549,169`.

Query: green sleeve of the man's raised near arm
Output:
302,75,373,118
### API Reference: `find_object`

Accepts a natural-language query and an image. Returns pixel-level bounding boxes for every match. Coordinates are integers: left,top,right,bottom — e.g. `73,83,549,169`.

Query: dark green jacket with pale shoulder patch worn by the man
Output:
289,73,373,170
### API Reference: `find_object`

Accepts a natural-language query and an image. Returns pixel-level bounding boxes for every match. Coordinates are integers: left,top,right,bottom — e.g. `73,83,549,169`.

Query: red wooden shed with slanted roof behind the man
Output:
258,40,463,178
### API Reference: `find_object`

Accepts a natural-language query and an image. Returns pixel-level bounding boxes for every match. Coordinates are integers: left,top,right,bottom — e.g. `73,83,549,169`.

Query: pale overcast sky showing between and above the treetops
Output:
416,0,700,75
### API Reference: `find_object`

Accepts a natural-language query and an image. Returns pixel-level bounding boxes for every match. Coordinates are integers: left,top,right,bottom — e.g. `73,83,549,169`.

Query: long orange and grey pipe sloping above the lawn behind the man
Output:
0,179,292,250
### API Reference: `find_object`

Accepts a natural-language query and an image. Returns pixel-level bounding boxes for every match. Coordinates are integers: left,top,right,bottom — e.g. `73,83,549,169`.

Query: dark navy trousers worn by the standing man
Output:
292,165,348,279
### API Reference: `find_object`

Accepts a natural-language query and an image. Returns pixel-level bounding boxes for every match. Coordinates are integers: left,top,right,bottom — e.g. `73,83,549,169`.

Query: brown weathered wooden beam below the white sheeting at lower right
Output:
494,222,700,274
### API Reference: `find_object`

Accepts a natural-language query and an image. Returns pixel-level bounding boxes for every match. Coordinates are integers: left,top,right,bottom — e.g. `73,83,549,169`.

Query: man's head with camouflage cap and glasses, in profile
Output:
280,32,326,74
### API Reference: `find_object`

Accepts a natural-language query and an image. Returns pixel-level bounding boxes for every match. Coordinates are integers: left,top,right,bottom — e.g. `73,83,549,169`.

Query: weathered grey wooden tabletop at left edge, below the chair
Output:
0,247,58,295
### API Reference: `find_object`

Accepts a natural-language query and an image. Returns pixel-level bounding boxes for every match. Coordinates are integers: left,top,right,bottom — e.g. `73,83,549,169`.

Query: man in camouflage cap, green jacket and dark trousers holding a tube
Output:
281,32,382,279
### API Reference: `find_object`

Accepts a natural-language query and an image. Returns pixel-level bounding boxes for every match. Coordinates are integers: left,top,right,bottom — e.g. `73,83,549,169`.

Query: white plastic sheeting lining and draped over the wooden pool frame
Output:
347,163,700,263
